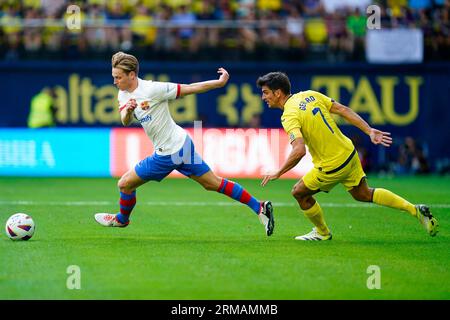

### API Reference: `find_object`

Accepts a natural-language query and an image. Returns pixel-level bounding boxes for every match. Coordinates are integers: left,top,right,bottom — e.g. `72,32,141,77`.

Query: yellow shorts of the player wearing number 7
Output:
303,153,366,192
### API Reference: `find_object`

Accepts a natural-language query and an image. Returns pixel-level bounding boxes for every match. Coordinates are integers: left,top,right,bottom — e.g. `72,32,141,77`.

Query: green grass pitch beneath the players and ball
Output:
0,177,450,300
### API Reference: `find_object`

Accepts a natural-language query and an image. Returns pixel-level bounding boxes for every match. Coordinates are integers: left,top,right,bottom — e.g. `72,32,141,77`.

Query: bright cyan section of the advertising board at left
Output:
0,128,111,177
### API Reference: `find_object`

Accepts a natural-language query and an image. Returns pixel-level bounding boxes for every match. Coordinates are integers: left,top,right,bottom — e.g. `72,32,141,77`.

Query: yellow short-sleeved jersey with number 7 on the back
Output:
281,90,355,172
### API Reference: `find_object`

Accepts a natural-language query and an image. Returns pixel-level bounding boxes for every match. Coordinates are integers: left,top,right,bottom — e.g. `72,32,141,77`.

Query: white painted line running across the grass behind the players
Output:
0,200,450,208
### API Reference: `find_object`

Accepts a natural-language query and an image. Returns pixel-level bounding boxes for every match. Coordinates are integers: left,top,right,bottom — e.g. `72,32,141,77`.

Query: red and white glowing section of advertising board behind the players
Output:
110,128,313,179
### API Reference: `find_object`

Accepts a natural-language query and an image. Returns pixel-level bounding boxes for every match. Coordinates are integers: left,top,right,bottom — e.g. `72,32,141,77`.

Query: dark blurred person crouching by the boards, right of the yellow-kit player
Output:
394,137,430,174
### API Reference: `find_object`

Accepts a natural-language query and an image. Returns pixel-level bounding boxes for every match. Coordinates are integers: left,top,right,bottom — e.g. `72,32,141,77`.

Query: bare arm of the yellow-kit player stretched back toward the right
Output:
330,102,392,147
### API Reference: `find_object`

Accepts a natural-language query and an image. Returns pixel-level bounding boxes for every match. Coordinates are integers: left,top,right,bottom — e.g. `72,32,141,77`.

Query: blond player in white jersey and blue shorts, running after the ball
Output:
95,52,275,236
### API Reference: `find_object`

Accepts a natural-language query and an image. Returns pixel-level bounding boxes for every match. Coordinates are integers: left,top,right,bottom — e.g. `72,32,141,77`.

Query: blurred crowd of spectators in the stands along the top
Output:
0,0,450,61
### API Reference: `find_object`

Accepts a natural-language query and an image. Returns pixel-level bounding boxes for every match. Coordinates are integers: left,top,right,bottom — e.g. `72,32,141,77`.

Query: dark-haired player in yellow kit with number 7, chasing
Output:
256,72,438,241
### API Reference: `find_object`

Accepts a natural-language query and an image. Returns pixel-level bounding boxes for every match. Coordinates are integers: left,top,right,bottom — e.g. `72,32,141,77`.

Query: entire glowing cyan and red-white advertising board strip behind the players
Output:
0,128,312,179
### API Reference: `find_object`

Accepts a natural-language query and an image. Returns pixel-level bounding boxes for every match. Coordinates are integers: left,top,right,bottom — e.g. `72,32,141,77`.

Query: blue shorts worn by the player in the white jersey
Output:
134,135,211,182
